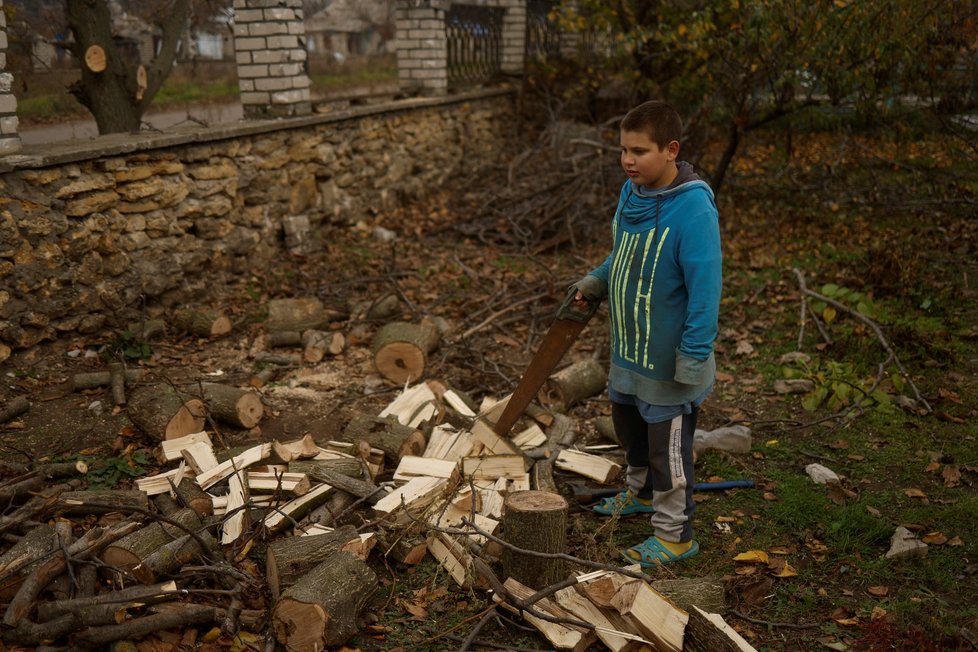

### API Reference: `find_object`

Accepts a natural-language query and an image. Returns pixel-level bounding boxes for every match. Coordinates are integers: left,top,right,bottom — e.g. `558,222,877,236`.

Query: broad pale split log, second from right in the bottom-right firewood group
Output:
582,573,689,652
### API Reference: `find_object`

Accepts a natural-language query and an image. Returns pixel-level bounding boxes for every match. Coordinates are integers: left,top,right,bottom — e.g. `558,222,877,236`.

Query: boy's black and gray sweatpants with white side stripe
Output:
611,402,699,543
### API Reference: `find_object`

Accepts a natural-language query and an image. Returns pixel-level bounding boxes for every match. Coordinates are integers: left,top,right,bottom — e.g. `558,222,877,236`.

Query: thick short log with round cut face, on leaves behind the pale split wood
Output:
370,321,441,385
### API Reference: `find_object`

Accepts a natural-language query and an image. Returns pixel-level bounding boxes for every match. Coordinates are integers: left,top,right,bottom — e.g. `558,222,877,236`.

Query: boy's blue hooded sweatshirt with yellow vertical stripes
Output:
587,162,722,405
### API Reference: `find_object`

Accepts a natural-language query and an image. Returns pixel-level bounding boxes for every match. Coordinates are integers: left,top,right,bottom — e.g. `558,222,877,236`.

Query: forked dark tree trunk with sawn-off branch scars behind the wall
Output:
65,0,190,134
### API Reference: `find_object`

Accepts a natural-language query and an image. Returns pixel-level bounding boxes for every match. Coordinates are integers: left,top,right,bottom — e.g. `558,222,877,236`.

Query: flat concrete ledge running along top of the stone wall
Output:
0,87,516,174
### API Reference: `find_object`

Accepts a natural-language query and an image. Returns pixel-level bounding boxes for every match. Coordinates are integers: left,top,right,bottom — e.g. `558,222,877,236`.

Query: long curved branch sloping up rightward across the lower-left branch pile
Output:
2,522,139,627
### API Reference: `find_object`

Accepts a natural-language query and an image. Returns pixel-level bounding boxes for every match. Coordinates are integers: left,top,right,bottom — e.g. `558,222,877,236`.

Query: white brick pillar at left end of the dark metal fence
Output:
395,0,450,95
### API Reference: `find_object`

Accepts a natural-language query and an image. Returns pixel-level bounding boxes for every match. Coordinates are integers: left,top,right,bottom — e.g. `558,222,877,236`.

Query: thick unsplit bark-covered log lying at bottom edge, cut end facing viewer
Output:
272,552,377,652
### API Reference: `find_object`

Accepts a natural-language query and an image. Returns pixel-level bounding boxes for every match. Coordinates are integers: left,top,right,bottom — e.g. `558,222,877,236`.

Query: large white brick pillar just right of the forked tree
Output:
234,0,312,118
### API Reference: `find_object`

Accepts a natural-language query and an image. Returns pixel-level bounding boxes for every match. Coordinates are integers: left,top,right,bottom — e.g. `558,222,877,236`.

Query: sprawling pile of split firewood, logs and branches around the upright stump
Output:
0,372,750,650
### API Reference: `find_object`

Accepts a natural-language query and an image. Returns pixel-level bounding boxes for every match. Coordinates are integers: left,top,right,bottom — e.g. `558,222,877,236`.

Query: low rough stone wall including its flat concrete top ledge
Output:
0,89,516,362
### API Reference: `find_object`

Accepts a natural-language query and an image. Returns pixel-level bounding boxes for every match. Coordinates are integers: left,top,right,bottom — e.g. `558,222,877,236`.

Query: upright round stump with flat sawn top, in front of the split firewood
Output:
502,490,567,589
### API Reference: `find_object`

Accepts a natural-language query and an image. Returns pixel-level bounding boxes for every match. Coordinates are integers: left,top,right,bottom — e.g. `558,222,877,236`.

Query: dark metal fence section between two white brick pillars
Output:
445,4,503,88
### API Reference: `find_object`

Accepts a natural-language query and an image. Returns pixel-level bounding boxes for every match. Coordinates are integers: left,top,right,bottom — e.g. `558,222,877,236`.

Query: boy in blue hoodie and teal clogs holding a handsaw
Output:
558,101,722,568
